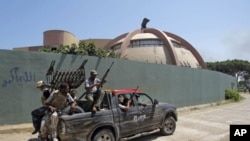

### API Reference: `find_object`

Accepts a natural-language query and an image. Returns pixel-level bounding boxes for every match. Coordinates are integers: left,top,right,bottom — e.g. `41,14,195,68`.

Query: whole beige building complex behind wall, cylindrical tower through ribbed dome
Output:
14,28,207,69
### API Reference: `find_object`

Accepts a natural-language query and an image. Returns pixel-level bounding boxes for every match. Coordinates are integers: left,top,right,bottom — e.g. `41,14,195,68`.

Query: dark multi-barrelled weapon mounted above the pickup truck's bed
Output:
46,59,88,90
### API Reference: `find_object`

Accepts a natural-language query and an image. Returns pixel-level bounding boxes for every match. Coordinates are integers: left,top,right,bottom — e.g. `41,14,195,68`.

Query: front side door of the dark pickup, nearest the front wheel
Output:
135,93,162,131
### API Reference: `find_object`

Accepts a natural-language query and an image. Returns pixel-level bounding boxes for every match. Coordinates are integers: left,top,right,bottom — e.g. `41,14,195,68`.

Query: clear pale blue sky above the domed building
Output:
0,0,250,62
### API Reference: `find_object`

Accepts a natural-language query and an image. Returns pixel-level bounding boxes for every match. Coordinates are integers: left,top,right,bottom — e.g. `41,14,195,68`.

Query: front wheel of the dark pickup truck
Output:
160,116,176,135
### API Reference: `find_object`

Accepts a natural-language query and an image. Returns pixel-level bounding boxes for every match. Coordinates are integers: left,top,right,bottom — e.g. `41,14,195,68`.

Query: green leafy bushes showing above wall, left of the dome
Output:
39,41,119,58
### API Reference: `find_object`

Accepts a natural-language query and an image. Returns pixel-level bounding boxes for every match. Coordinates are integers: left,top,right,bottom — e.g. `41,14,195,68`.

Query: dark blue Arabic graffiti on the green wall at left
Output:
1,67,36,88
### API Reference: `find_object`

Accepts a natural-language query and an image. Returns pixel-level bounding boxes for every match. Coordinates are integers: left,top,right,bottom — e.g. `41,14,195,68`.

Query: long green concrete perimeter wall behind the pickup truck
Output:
0,50,236,125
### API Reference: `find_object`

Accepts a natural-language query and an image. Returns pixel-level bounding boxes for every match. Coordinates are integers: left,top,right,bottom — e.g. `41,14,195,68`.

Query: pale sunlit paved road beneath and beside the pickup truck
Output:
0,94,250,141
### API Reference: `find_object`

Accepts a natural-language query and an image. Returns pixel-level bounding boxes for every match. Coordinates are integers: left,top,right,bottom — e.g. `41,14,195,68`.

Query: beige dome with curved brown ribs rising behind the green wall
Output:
104,28,207,69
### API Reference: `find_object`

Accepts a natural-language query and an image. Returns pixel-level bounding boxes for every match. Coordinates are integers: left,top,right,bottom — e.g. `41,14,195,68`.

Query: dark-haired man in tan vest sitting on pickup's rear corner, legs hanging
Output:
41,83,76,141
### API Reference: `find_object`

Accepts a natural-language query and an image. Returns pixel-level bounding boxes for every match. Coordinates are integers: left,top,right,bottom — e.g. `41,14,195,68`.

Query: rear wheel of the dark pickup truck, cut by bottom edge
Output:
93,129,115,141
